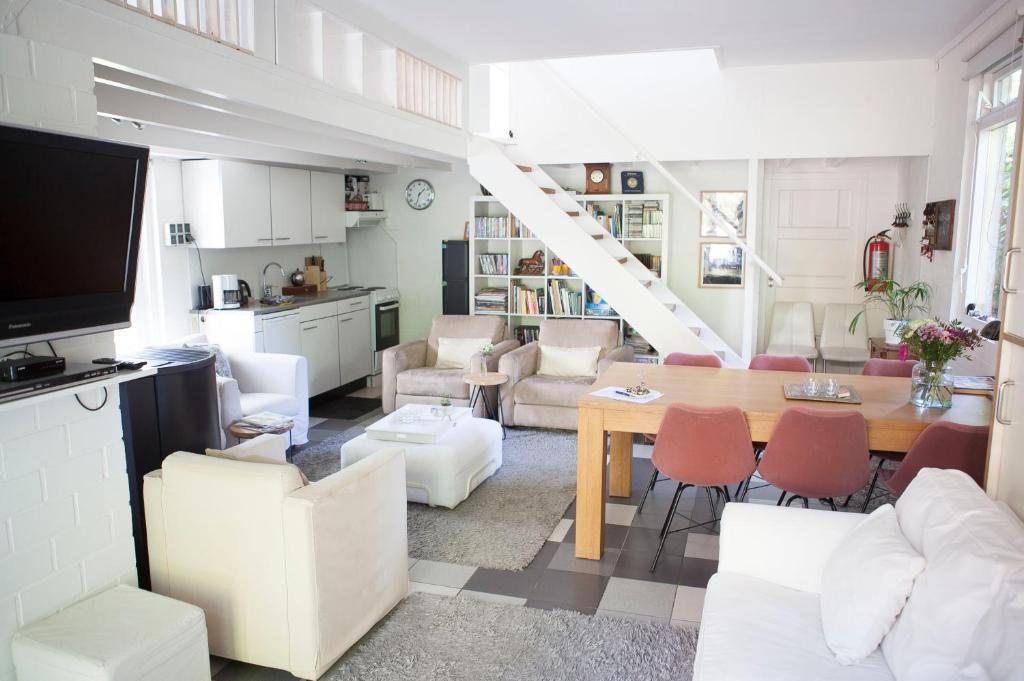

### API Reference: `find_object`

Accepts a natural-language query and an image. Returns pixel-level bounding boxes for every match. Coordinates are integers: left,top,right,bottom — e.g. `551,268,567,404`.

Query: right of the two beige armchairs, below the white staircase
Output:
498,320,633,430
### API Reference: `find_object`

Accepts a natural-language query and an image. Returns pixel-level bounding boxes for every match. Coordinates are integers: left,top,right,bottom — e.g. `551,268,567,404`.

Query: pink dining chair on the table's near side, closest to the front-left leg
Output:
650,403,755,572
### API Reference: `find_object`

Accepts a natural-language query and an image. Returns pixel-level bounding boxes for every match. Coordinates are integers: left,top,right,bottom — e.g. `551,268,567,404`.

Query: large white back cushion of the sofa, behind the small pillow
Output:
882,468,1024,681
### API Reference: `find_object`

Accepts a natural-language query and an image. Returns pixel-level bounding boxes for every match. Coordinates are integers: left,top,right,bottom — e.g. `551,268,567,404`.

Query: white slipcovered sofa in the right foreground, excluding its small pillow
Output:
693,469,1024,681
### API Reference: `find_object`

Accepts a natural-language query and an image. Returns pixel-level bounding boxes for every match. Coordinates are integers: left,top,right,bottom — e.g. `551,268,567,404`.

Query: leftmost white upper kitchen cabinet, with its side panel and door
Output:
181,161,273,248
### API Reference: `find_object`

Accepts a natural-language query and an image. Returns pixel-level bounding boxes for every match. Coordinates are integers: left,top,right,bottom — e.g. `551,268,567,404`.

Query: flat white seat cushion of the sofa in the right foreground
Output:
693,572,893,681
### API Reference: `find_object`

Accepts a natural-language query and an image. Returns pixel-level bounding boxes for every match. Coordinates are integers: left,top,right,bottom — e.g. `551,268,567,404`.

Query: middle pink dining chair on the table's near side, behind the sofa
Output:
758,408,871,511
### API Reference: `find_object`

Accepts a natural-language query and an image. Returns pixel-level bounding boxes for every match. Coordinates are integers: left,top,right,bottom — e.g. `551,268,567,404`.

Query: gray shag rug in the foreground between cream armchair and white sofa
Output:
324,593,697,681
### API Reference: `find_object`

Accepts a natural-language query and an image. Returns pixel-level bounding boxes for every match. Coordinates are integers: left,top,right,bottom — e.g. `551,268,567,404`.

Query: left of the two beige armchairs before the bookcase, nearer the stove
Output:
381,314,519,415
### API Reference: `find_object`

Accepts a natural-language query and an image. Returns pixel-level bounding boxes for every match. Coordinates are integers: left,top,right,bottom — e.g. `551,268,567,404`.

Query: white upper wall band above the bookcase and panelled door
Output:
512,50,935,163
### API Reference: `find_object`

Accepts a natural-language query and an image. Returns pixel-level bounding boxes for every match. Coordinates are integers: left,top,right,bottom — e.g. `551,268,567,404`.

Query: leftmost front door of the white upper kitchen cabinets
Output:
221,161,272,248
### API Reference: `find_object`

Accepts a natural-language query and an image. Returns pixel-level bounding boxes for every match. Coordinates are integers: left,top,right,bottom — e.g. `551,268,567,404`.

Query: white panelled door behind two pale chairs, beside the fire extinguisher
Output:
758,173,867,348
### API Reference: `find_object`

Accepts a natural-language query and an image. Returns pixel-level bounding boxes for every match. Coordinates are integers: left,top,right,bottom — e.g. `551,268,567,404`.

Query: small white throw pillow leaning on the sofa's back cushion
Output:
821,504,925,665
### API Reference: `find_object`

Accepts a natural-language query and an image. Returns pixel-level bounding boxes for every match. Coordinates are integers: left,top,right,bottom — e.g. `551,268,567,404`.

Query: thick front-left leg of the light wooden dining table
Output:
575,409,605,560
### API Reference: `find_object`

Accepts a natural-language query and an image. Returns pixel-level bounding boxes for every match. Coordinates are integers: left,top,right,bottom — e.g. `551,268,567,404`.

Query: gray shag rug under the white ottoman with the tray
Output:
293,426,575,570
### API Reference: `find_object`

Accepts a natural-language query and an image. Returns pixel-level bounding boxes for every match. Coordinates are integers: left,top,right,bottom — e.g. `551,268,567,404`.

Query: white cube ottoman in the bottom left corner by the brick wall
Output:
11,586,210,681
